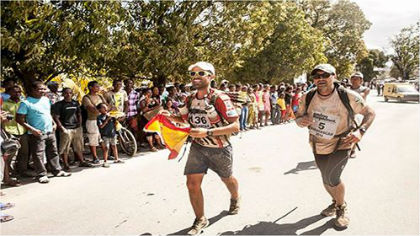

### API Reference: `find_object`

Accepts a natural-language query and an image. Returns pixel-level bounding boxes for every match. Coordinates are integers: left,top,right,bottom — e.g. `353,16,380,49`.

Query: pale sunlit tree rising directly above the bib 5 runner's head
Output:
298,0,371,78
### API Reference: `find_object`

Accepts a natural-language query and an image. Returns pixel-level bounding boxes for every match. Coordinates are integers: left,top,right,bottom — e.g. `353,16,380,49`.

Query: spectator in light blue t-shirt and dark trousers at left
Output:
16,81,71,183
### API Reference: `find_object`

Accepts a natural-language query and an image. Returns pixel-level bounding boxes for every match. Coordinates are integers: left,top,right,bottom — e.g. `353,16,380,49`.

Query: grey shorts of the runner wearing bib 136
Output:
184,142,233,178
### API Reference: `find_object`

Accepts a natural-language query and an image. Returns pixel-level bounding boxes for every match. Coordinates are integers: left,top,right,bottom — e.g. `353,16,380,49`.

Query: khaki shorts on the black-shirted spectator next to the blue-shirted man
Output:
59,127,83,154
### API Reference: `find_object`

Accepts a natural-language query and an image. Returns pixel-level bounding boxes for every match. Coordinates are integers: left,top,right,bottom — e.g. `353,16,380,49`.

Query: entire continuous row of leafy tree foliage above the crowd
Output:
1,0,376,87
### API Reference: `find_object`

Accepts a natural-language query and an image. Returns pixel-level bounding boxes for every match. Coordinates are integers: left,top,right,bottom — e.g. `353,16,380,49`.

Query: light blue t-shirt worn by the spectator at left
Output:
17,96,53,133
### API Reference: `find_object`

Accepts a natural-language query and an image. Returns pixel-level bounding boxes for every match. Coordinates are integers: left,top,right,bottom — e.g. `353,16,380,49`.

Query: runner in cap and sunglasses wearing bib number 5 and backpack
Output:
296,64,375,228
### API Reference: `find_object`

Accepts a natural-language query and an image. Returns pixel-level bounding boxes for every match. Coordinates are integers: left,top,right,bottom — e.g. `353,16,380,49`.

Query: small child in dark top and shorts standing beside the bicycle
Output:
96,103,124,167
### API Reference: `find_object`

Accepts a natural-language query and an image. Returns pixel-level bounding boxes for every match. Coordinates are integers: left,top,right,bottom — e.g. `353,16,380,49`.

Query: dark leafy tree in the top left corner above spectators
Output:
1,1,121,87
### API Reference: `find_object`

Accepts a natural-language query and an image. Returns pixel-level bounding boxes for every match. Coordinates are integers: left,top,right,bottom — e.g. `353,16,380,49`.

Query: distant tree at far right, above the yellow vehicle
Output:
390,22,420,80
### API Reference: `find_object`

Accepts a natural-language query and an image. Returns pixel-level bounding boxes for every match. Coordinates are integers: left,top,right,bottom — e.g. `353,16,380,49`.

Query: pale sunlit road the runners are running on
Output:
1,91,420,235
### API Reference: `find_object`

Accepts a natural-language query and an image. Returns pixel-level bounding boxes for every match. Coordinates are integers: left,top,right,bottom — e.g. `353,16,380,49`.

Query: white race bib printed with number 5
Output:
309,111,340,139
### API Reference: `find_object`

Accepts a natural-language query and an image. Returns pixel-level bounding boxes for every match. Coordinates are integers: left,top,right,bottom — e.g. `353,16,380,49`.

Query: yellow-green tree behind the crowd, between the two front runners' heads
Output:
234,3,326,83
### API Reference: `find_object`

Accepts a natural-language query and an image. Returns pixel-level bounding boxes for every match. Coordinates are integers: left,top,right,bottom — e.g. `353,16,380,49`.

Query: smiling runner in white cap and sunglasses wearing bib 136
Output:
161,62,240,235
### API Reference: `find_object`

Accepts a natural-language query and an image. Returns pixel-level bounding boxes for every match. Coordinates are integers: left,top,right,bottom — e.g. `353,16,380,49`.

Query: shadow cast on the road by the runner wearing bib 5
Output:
221,215,334,235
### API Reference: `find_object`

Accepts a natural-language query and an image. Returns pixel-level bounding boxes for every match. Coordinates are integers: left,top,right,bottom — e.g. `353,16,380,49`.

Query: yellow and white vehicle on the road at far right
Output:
383,83,419,102
